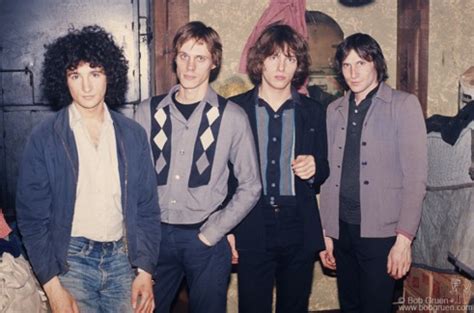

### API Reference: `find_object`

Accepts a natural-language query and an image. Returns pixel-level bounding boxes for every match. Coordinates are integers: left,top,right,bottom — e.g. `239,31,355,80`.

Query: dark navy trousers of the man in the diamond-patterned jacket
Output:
154,224,231,313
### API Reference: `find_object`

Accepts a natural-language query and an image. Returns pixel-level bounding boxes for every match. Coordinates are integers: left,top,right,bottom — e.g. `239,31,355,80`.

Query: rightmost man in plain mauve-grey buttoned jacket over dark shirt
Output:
320,33,427,313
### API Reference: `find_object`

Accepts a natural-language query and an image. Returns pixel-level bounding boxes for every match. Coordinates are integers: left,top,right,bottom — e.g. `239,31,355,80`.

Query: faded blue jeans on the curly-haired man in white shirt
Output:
59,237,134,313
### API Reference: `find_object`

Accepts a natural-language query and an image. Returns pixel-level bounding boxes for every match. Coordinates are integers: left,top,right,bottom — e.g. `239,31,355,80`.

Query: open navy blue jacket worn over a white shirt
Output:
16,108,161,284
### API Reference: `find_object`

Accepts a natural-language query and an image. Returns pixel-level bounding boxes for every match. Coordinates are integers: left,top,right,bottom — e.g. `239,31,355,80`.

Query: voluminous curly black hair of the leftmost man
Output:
41,25,128,108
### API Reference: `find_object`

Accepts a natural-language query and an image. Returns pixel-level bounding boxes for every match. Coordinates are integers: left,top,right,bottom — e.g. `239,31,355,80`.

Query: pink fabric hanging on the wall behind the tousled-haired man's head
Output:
239,0,308,74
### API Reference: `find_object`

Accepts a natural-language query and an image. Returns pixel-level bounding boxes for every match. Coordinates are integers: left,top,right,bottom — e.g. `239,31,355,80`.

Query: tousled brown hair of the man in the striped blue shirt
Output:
247,23,311,88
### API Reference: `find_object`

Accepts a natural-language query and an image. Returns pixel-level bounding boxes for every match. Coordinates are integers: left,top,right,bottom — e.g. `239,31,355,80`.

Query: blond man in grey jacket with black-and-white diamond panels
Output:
136,22,261,313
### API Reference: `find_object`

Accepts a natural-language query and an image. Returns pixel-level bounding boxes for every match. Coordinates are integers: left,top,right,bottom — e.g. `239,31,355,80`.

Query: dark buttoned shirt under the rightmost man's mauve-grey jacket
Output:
339,86,378,224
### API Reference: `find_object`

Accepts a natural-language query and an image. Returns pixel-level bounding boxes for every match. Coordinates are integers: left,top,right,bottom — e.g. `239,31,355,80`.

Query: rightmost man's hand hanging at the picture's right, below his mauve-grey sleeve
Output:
387,234,411,279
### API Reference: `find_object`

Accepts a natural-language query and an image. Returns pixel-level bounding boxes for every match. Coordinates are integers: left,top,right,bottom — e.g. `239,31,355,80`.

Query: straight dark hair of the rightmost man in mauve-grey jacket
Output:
335,33,388,89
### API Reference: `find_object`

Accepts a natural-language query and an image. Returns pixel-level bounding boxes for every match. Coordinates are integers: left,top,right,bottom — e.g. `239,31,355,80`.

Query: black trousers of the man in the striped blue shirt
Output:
237,207,315,313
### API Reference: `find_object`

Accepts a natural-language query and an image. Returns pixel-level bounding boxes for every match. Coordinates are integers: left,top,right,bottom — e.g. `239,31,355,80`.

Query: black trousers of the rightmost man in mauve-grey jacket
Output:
334,221,395,313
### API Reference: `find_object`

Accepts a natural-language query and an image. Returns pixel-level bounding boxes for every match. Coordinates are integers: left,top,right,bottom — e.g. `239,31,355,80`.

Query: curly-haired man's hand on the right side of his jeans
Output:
132,271,155,313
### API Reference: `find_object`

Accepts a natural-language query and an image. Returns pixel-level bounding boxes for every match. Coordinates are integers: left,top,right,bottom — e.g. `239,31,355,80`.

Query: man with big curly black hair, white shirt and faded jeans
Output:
16,26,160,312
